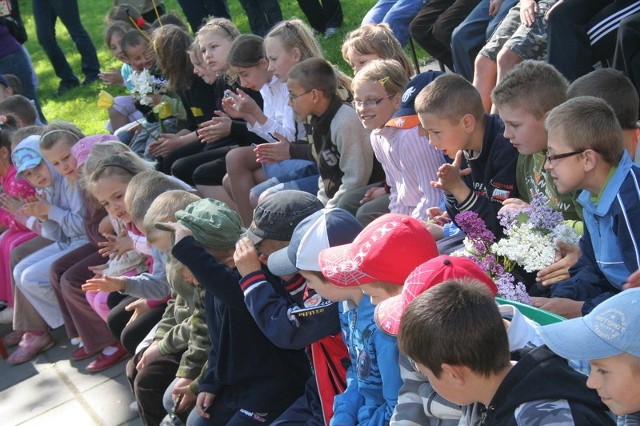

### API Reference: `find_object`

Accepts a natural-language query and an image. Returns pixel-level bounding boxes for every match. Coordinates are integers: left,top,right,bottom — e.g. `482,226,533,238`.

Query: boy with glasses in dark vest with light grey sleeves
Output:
261,58,381,208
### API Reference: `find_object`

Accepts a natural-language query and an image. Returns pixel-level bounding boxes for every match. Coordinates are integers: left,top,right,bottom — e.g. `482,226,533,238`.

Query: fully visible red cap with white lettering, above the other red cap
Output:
318,213,438,287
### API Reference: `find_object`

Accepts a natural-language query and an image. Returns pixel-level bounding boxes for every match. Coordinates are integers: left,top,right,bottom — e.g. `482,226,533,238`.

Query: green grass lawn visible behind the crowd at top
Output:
20,0,424,134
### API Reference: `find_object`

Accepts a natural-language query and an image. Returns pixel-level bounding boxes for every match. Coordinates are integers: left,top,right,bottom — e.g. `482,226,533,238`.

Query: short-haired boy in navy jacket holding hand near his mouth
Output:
415,74,519,238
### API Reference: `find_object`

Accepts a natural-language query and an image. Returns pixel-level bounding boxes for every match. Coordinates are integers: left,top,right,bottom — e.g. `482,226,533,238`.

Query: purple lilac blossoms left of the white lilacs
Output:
453,211,531,305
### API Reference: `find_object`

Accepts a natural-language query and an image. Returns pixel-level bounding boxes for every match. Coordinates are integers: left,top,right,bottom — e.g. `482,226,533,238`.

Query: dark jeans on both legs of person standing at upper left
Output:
33,0,100,85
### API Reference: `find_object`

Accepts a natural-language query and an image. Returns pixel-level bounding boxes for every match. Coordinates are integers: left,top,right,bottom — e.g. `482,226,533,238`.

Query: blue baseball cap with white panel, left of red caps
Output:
267,209,362,276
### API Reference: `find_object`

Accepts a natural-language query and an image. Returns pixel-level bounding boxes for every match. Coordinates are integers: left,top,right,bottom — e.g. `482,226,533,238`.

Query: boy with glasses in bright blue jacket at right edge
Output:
534,96,640,317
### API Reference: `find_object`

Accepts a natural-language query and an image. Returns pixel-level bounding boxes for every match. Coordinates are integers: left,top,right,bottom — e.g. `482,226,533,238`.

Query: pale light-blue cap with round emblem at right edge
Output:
540,288,640,360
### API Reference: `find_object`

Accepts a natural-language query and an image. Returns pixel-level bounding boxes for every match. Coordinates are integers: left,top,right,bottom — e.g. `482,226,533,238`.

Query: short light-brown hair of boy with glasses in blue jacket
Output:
544,96,624,166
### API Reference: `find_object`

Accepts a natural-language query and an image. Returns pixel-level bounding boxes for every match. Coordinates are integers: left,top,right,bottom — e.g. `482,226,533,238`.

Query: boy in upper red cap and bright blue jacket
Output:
316,214,437,424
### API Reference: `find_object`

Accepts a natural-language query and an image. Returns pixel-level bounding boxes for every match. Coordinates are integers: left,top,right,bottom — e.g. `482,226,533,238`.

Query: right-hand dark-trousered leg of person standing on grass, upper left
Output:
48,0,100,82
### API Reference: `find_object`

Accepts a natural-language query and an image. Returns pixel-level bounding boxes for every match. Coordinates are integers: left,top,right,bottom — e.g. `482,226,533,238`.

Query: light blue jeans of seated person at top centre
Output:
362,0,428,46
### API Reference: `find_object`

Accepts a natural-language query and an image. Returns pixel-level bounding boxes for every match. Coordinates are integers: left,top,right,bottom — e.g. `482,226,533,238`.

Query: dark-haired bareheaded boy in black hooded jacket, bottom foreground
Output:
398,278,613,425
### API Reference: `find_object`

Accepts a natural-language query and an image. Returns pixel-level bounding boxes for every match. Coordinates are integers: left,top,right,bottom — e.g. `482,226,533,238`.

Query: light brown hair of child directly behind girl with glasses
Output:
342,24,413,78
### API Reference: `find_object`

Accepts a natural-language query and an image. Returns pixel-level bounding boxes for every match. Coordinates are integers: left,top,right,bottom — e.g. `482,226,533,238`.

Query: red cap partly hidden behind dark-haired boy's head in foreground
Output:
374,255,498,336
